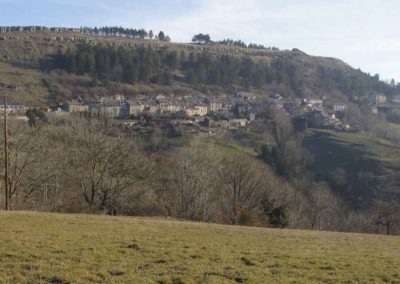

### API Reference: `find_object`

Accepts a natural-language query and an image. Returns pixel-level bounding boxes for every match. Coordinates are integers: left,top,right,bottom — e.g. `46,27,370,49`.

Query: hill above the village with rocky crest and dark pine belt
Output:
0,29,396,104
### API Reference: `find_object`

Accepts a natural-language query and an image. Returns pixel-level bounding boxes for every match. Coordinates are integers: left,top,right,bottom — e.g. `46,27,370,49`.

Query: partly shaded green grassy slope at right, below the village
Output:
305,129,400,208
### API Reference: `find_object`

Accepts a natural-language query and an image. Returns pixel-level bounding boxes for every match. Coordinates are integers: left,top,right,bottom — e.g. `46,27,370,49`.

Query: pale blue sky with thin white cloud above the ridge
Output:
0,0,400,81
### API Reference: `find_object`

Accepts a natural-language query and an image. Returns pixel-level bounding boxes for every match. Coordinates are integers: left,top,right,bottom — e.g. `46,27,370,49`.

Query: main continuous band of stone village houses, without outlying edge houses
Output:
59,92,359,131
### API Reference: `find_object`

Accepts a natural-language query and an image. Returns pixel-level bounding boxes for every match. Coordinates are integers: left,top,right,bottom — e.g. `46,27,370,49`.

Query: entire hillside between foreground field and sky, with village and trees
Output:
0,29,400,234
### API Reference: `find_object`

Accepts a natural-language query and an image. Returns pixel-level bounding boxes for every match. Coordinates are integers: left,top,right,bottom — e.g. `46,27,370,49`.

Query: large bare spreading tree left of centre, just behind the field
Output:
71,118,153,214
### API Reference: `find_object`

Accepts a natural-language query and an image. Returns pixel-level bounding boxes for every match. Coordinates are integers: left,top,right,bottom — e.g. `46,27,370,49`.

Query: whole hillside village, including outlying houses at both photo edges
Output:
0,91,400,135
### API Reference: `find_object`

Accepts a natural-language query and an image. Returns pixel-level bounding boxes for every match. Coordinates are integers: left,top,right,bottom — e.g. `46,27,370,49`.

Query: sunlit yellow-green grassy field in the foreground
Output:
0,211,400,283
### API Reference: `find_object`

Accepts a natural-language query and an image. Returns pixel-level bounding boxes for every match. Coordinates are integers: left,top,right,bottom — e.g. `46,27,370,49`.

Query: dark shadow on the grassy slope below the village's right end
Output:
305,131,388,207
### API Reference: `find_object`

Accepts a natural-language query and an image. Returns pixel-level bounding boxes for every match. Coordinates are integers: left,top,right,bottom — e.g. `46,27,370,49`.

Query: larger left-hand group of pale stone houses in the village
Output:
58,93,255,127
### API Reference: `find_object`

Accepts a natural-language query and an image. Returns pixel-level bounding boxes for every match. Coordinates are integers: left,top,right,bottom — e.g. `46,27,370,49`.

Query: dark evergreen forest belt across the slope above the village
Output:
41,44,400,96
